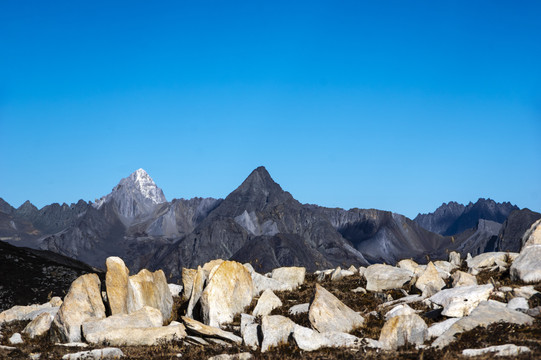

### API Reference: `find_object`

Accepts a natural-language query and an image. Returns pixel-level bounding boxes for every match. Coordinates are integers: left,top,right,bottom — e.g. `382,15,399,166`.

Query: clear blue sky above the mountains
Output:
0,0,541,217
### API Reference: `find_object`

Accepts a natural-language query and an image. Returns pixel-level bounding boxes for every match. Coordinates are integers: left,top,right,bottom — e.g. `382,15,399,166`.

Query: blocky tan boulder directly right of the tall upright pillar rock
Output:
127,269,173,321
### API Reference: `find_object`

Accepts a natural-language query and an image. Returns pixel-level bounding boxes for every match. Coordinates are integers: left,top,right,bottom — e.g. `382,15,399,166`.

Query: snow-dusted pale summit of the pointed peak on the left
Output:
94,169,167,223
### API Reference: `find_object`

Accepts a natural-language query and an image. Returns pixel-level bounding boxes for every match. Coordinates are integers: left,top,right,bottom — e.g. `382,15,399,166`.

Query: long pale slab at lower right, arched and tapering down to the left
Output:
432,301,533,349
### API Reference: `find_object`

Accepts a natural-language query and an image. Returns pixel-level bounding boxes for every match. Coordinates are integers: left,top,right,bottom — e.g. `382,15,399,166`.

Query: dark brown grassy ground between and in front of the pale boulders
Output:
0,272,541,360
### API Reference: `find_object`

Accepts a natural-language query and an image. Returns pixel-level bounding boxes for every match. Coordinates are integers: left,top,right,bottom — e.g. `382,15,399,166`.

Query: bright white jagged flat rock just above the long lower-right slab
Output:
428,284,494,317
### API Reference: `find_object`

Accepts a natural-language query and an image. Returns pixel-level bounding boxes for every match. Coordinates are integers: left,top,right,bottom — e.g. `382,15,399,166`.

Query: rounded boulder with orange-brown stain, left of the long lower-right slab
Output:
379,314,428,350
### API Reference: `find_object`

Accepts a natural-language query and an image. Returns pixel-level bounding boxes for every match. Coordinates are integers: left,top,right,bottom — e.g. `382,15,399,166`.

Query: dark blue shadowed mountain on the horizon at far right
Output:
414,198,519,236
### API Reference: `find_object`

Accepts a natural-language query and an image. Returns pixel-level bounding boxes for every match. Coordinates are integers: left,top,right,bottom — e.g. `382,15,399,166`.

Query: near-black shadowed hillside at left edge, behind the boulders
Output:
0,241,104,311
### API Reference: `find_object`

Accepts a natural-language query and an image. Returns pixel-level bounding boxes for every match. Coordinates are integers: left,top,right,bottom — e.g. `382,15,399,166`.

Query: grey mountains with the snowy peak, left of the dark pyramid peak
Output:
0,169,220,271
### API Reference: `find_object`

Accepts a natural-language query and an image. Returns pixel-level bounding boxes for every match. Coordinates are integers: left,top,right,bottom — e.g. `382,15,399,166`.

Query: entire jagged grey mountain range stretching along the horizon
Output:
0,167,541,279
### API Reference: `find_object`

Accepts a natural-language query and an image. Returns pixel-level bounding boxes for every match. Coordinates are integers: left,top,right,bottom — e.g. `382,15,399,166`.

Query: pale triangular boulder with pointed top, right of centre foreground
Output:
308,284,364,332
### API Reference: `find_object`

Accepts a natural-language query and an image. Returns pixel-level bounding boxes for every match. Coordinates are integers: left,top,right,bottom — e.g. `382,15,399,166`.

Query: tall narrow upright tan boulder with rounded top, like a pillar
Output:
105,256,130,315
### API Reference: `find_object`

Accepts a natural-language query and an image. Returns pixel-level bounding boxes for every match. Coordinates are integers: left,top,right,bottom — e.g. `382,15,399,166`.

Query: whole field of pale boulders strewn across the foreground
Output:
0,220,541,359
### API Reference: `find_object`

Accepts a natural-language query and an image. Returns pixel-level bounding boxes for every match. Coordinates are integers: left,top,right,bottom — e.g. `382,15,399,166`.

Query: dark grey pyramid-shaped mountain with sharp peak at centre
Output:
151,167,367,276
